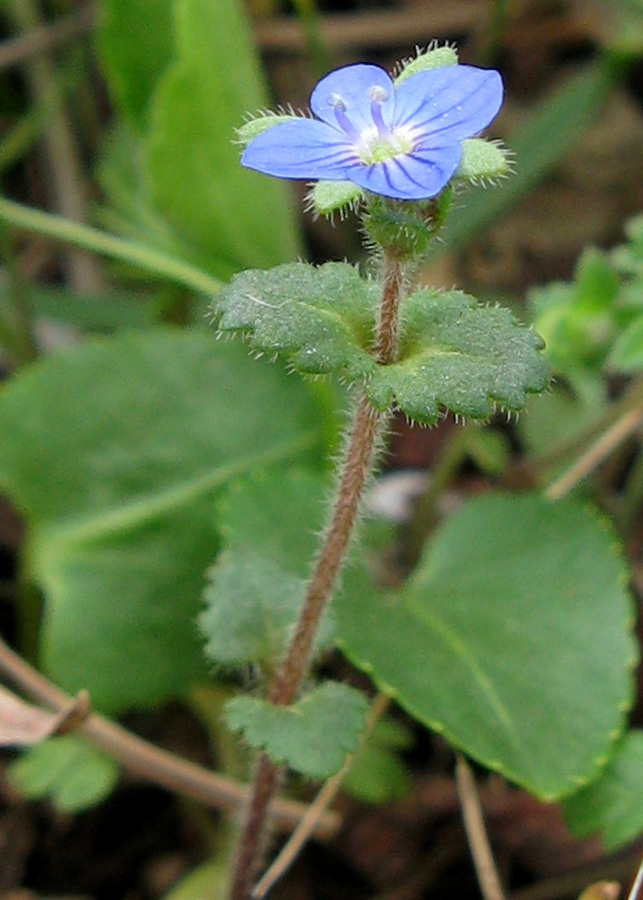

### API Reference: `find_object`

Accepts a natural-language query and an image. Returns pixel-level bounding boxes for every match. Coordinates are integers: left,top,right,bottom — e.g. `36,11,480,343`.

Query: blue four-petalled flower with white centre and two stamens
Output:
241,63,503,200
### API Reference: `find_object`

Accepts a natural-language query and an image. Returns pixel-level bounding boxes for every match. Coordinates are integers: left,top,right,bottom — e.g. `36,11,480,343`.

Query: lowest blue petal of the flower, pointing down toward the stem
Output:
345,143,462,200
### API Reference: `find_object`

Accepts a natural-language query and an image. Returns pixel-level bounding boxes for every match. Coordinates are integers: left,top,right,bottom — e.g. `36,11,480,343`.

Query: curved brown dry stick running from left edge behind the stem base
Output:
0,640,340,839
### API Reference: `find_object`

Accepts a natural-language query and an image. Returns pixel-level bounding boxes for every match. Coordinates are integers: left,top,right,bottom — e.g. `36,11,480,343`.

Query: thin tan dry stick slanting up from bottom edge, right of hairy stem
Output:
252,694,390,900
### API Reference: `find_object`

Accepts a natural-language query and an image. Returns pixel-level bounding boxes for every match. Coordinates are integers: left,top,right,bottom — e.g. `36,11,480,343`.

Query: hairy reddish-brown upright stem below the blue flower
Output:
228,253,402,900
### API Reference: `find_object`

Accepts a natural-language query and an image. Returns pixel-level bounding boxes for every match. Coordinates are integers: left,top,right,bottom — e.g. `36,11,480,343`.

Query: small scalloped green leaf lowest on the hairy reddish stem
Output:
226,681,368,779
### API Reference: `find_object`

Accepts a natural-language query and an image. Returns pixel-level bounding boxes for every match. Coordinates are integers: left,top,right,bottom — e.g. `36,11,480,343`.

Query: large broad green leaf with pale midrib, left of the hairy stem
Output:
0,329,325,709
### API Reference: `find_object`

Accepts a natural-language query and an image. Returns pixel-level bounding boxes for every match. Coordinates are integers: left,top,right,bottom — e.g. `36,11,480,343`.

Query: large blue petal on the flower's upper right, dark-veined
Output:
395,66,503,146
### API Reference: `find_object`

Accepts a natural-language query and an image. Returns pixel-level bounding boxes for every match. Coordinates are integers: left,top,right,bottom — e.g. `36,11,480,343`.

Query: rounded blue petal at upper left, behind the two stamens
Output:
310,63,394,131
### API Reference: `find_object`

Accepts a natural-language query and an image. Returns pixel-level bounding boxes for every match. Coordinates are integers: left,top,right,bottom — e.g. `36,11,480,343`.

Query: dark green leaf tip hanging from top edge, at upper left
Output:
96,0,173,129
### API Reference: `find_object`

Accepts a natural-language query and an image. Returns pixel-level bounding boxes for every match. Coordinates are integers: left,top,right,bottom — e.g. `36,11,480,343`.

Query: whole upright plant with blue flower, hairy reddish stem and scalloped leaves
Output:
210,48,547,900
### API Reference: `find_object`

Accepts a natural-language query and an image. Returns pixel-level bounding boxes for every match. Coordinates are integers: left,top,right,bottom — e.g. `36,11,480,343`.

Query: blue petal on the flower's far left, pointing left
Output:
241,119,355,180
